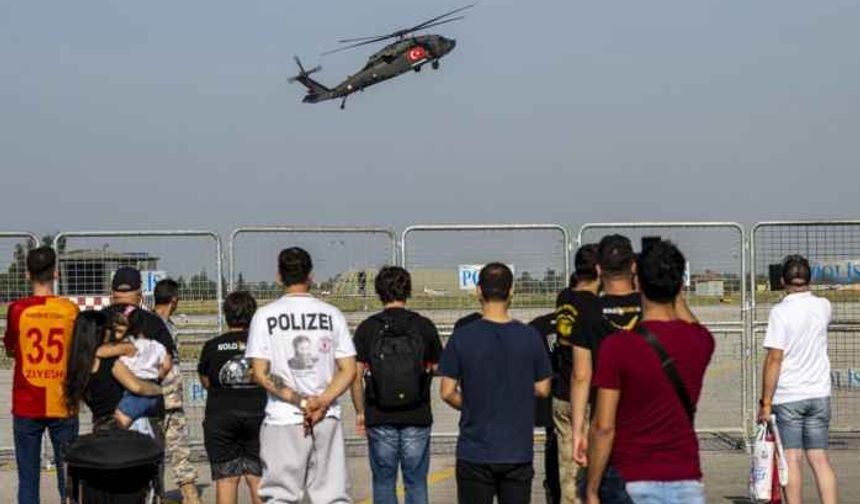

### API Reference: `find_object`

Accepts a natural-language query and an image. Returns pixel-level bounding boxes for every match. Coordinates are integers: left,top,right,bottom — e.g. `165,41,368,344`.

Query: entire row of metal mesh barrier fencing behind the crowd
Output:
5,221,860,458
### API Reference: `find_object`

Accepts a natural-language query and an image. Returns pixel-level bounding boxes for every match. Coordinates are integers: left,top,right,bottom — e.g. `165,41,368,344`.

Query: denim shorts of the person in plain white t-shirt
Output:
773,397,830,450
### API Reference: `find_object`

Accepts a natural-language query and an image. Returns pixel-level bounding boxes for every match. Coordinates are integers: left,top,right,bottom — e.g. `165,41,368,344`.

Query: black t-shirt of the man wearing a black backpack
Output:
354,308,442,427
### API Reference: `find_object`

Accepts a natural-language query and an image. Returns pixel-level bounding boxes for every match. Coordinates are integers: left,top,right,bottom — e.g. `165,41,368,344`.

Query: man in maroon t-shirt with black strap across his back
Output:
585,242,714,504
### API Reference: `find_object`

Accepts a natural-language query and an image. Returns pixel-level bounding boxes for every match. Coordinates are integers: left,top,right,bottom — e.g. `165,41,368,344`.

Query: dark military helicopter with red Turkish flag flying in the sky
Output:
288,4,475,110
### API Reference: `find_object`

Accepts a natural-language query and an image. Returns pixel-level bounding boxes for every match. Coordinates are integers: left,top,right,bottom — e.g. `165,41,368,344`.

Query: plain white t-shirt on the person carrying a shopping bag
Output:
764,292,831,404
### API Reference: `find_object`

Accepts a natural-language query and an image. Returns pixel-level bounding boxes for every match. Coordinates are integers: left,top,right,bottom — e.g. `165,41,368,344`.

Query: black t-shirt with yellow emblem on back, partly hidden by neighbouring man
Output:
552,289,603,401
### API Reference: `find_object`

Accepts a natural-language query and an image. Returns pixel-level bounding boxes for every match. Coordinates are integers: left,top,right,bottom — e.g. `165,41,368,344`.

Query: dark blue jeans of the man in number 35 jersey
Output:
13,416,78,504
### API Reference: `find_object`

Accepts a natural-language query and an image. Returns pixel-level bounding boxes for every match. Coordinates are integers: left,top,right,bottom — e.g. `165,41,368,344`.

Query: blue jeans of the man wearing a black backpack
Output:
367,425,430,504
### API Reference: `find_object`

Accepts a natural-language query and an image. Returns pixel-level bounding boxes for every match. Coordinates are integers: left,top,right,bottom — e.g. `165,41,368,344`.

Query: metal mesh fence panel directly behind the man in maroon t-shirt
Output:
577,222,752,433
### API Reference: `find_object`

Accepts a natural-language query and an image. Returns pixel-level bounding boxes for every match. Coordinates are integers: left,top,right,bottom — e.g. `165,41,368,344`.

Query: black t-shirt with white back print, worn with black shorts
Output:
197,331,266,416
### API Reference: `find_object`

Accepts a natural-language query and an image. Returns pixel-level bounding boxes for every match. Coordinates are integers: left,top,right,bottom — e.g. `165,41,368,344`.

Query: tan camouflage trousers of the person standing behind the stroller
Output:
161,364,197,486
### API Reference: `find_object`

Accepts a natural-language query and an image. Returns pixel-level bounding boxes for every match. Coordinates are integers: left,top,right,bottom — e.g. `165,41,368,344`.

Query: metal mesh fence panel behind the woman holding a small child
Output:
54,230,226,442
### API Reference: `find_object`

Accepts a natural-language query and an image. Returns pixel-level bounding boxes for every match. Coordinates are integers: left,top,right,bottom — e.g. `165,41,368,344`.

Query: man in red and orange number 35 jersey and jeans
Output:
3,247,78,504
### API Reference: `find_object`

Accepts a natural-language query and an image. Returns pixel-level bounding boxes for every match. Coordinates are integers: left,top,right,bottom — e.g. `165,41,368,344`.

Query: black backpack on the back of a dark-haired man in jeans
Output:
365,313,430,410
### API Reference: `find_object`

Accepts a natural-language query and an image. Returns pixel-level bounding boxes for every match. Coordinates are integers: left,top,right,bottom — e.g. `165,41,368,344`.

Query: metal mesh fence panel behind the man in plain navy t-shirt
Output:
401,224,570,327
